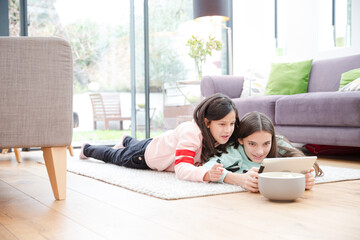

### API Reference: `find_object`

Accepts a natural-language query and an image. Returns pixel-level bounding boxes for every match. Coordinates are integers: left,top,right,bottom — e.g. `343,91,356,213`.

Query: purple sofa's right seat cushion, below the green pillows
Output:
275,92,360,127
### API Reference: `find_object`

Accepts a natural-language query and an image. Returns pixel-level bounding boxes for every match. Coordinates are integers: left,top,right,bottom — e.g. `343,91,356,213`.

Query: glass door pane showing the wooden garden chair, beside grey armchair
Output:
27,0,131,145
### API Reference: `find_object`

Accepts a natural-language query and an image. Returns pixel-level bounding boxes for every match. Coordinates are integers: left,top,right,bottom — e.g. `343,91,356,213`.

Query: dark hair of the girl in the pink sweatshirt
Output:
193,93,239,163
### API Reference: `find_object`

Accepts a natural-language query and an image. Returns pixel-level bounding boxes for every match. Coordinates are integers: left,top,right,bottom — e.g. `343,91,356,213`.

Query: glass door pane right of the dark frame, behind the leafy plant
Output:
149,0,227,136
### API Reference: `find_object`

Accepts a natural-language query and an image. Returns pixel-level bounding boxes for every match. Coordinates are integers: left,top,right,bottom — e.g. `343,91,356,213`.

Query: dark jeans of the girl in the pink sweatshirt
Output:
84,136,152,169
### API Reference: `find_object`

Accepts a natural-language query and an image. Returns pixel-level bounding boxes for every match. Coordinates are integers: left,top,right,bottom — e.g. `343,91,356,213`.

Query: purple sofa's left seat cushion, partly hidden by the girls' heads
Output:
232,95,283,122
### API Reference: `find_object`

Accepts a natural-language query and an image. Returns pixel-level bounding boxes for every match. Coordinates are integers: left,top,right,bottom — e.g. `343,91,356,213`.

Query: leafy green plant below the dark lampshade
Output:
186,36,223,81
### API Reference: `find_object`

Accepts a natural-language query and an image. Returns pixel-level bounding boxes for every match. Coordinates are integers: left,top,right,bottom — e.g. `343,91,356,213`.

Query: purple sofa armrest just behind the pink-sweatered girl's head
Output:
200,76,244,98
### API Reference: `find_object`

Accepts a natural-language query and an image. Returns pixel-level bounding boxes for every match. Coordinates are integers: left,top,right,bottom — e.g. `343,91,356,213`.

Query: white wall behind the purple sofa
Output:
233,0,360,75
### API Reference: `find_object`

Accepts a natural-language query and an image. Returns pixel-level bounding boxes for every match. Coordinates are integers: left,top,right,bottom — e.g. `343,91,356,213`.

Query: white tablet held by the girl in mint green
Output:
259,156,317,173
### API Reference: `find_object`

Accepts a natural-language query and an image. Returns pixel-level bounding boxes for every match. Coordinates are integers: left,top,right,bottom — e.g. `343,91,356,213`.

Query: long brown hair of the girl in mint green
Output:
234,112,323,176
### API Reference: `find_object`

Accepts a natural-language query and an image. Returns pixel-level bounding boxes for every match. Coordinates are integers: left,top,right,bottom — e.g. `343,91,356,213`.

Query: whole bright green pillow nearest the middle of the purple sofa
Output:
266,59,312,95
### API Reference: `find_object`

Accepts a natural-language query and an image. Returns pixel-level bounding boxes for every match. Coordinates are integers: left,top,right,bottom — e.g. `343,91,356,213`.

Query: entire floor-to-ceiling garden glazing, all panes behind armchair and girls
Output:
5,0,227,145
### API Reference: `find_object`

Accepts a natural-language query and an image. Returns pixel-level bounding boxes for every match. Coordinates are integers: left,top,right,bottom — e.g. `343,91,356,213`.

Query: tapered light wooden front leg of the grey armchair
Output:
41,147,66,200
